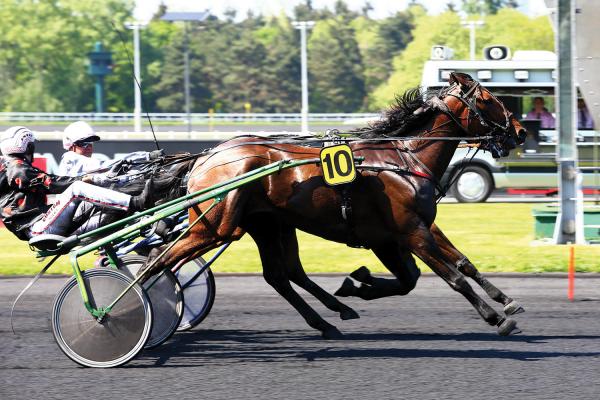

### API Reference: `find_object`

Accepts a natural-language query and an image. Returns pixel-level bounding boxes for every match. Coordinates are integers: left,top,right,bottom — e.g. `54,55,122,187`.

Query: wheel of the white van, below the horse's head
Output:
452,165,494,203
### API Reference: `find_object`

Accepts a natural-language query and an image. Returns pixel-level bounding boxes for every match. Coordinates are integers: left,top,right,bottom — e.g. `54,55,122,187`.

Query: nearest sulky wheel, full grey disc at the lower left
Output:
52,268,152,368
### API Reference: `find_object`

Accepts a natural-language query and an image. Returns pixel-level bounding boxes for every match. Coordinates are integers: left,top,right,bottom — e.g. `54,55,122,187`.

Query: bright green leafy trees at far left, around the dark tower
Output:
0,0,132,111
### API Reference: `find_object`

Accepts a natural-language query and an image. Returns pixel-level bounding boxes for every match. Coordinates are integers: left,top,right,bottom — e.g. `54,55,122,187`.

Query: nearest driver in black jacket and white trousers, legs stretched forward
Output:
0,126,152,240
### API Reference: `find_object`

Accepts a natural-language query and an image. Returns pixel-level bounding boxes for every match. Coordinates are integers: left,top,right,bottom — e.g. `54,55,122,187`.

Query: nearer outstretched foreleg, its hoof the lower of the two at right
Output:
407,225,517,336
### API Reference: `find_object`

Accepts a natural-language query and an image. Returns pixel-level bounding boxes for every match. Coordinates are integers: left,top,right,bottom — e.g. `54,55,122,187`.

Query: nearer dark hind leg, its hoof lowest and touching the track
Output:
243,214,342,339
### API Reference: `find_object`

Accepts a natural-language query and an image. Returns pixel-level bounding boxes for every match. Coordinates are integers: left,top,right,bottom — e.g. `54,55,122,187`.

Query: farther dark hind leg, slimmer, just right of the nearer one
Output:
281,225,359,320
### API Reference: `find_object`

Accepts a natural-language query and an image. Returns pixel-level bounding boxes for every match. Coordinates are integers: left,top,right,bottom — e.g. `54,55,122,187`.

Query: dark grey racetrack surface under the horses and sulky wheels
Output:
0,275,600,400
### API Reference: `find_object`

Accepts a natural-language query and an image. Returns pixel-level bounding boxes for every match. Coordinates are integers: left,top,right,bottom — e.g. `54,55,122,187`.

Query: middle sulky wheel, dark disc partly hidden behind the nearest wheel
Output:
121,255,184,349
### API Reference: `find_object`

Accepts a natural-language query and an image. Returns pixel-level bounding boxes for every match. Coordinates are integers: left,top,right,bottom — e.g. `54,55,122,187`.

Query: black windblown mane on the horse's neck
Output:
358,87,438,139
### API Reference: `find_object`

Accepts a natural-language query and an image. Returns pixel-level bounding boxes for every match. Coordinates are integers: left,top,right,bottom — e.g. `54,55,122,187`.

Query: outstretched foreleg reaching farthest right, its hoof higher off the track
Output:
431,224,525,315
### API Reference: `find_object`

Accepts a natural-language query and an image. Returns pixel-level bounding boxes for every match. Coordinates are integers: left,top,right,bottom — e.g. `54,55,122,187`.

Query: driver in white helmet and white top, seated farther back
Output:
58,121,164,176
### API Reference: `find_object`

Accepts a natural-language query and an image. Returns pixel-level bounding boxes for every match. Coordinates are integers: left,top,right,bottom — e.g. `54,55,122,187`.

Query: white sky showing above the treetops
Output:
135,0,546,21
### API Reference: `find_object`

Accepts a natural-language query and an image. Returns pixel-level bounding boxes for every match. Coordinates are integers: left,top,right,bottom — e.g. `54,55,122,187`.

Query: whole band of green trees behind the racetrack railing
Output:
0,0,553,112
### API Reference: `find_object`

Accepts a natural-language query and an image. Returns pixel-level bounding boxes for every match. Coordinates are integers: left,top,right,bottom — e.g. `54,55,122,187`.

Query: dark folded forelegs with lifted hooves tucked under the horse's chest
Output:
336,243,421,300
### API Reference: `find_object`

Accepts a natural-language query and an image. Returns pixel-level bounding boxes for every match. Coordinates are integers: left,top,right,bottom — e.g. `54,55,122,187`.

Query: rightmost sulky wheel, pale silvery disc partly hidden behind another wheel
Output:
176,257,216,331
